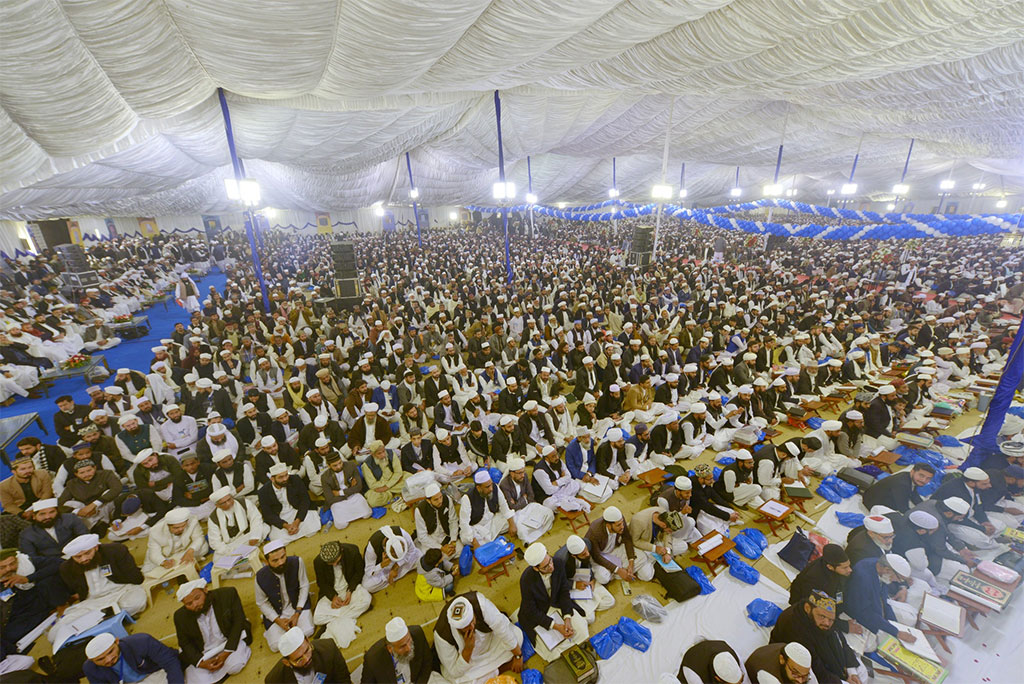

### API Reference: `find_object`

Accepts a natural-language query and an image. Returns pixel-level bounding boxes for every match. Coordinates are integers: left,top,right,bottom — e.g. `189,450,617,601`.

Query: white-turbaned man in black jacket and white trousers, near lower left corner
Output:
53,535,145,647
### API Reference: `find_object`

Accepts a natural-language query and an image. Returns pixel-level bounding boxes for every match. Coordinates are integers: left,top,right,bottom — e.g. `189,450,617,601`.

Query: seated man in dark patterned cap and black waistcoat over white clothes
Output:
313,542,373,648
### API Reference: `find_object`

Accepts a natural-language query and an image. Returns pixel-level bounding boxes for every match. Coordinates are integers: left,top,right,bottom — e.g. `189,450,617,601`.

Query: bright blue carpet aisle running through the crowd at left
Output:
0,268,226,479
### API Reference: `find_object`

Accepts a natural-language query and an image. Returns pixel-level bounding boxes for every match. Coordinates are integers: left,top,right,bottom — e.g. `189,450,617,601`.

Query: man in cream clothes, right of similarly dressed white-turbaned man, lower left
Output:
207,485,268,584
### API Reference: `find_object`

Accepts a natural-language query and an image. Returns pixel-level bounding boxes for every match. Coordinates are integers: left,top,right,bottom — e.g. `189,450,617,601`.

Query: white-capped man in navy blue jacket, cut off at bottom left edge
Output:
82,632,185,684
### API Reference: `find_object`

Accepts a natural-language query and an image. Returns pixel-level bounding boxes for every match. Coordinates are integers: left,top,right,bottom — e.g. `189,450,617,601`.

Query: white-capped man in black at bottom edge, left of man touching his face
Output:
360,617,433,684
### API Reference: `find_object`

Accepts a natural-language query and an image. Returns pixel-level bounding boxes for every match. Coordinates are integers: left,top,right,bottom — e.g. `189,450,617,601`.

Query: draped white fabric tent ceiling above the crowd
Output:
0,0,1024,218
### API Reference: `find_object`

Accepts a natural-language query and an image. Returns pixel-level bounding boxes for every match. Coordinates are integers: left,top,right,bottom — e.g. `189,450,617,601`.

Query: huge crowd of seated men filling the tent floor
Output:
0,215,1024,684
